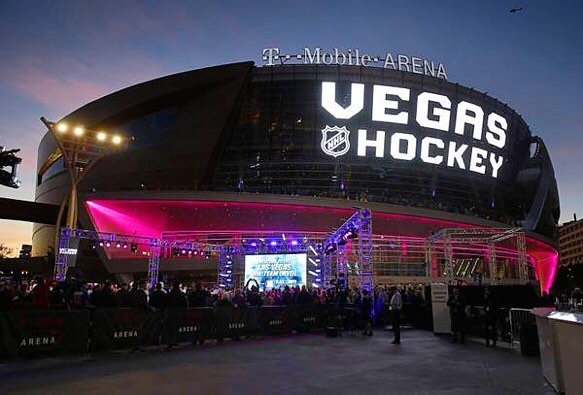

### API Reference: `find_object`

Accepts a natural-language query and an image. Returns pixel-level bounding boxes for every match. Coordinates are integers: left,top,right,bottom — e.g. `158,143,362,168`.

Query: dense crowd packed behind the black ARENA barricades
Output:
0,277,425,326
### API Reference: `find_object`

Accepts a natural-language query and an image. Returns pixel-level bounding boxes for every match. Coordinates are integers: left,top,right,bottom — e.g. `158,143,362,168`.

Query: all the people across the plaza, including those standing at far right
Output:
0,277,583,346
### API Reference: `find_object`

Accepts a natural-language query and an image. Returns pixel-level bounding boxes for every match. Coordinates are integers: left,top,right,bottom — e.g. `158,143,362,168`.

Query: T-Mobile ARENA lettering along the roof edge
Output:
262,47,447,80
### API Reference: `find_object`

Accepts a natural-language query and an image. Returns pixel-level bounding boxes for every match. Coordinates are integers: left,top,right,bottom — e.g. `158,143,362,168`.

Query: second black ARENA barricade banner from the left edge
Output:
91,308,160,350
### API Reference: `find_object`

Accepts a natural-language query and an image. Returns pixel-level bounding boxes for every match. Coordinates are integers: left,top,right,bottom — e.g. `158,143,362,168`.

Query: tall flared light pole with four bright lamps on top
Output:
41,117,127,281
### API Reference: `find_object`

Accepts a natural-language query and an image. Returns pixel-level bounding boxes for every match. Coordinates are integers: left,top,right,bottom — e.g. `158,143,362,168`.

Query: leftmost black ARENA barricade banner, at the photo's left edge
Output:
0,310,89,357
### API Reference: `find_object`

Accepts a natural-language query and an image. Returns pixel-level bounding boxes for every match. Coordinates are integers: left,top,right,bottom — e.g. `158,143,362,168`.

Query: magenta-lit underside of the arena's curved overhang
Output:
86,200,558,290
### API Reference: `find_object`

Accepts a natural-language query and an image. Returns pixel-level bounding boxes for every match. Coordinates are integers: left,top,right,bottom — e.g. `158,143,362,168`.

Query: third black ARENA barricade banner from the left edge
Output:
162,307,215,344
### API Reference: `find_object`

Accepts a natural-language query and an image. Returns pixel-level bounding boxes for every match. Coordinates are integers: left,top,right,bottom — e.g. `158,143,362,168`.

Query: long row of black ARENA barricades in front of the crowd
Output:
0,305,360,358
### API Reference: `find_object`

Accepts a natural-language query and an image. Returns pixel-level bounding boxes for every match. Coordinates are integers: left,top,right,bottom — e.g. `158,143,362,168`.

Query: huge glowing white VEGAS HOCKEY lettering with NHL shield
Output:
321,82,508,178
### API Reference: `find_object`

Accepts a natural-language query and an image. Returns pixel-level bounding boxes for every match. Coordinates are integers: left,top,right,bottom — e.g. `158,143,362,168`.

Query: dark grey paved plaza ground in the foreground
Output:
0,330,554,395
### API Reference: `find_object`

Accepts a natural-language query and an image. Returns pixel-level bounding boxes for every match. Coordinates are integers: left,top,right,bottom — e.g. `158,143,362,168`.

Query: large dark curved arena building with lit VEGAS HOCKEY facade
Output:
33,57,559,290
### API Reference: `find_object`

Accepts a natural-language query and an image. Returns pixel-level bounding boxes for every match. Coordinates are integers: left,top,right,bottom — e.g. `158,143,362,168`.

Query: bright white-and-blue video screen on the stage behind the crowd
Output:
245,254,307,290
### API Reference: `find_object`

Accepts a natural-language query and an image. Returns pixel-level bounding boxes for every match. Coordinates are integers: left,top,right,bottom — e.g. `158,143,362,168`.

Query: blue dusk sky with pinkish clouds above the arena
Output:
0,0,583,253
